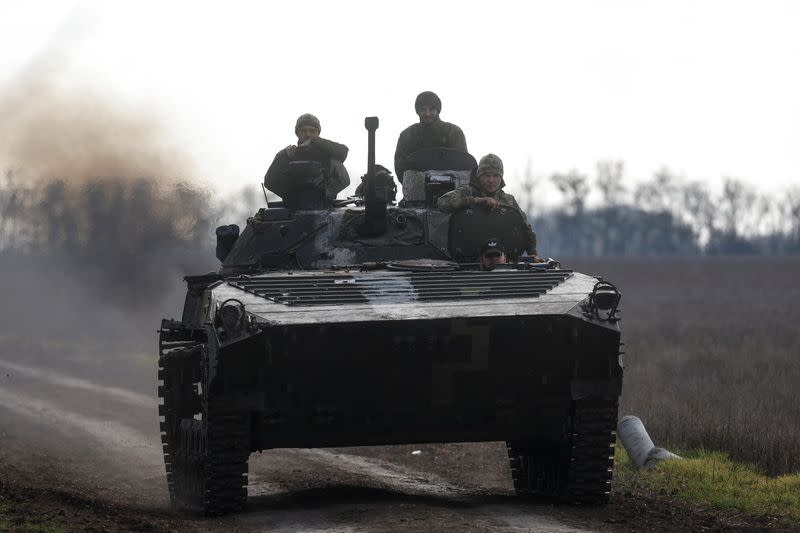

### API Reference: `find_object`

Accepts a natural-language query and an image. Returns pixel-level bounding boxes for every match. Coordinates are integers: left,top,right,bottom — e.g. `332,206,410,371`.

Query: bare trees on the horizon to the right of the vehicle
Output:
520,161,800,257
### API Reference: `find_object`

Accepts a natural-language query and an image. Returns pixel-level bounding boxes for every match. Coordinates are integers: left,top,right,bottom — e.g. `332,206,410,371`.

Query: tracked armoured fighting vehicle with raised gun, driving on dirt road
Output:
158,117,622,515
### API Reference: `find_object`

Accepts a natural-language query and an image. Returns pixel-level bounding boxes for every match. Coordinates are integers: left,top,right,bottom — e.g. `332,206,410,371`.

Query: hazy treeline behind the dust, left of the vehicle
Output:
0,171,262,256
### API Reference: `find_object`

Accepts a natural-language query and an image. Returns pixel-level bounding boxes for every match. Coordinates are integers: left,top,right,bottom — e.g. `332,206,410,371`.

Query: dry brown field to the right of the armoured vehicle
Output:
563,257,800,474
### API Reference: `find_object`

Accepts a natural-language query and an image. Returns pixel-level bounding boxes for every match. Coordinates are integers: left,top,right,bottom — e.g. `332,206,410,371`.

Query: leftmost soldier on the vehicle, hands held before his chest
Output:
264,113,350,203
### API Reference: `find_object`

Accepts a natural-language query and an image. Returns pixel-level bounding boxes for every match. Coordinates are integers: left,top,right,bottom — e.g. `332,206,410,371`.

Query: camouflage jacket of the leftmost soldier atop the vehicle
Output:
264,137,350,200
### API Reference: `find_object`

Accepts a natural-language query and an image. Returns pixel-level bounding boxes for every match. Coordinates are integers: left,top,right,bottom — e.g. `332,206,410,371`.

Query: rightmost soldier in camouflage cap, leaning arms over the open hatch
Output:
438,154,539,262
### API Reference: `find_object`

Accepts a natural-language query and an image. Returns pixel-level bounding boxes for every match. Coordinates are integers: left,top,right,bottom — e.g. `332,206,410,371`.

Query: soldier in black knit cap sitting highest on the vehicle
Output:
394,91,467,183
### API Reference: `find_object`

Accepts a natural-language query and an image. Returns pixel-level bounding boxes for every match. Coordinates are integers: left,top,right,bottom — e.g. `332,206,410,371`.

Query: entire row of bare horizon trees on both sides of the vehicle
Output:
0,161,800,262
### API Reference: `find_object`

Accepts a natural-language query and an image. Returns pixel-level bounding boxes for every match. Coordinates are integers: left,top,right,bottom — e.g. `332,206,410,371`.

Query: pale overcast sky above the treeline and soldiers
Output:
0,0,800,204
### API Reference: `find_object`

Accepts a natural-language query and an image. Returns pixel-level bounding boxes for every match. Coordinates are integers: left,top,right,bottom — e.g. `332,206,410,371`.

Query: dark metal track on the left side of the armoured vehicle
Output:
158,321,250,516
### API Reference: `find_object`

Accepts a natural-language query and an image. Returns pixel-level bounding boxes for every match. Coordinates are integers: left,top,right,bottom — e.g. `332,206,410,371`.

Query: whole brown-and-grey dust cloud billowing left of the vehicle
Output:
0,54,220,349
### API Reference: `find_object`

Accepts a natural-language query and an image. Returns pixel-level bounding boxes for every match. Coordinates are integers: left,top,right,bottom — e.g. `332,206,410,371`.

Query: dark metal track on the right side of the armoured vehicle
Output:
506,400,617,505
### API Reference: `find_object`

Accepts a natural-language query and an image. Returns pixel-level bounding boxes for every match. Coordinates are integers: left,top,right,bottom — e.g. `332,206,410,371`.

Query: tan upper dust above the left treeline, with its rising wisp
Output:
0,6,195,184
